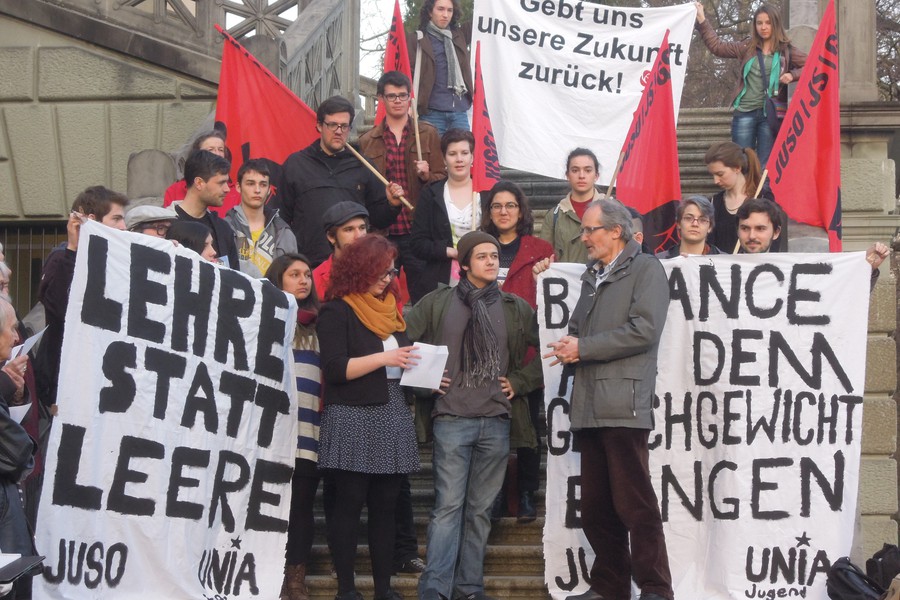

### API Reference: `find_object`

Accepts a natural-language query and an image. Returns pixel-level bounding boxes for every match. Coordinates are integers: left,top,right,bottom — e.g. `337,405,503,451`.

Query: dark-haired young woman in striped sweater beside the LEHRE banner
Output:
266,253,322,600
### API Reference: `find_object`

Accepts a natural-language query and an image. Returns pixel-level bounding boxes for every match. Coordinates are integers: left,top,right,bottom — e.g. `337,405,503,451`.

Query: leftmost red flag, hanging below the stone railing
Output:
216,25,319,181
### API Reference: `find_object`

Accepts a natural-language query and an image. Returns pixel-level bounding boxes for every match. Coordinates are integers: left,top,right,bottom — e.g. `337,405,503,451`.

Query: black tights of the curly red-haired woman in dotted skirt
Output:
327,470,402,598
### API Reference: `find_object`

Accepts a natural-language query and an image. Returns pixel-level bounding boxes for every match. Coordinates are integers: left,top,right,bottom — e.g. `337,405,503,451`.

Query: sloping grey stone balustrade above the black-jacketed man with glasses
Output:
279,0,359,109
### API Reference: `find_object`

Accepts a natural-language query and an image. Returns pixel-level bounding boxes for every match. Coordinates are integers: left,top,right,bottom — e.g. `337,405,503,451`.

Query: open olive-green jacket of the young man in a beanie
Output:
406,284,544,448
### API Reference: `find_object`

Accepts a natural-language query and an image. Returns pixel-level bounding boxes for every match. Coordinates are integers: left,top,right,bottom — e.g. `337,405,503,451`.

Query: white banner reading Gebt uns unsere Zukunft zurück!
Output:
472,0,697,185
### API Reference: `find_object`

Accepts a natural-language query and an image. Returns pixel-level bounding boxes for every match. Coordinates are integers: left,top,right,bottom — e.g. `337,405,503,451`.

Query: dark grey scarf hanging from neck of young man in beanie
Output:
456,277,500,388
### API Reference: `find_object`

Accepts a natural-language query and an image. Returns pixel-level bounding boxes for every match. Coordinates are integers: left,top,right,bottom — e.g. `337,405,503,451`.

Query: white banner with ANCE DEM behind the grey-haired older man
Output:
538,252,871,600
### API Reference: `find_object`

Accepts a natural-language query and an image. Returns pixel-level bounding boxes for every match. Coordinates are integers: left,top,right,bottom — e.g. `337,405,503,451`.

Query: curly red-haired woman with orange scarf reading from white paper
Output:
316,235,419,600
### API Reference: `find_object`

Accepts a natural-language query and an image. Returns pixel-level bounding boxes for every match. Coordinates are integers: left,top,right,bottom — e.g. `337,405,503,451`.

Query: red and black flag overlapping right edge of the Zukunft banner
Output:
616,30,681,251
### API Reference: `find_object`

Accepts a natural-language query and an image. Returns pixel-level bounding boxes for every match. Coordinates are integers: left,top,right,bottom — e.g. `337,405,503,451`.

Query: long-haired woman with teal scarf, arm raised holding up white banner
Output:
695,2,806,166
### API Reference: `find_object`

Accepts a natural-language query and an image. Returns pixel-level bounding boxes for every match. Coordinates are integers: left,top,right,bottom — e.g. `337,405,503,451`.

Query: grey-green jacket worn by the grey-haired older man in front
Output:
569,240,669,430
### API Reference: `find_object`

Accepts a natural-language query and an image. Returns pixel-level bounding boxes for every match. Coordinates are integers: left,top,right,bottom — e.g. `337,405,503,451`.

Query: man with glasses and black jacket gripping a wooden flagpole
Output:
272,96,402,268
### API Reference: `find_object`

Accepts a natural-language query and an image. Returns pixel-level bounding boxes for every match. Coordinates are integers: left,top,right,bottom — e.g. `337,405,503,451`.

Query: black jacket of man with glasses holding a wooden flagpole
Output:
273,140,400,267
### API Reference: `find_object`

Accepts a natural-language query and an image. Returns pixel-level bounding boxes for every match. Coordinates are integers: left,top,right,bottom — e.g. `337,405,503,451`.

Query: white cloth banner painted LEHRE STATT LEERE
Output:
35,221,297,600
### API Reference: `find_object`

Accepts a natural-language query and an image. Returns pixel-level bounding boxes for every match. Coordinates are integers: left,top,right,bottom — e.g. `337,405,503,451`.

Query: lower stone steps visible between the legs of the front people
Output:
307,444,549,600
